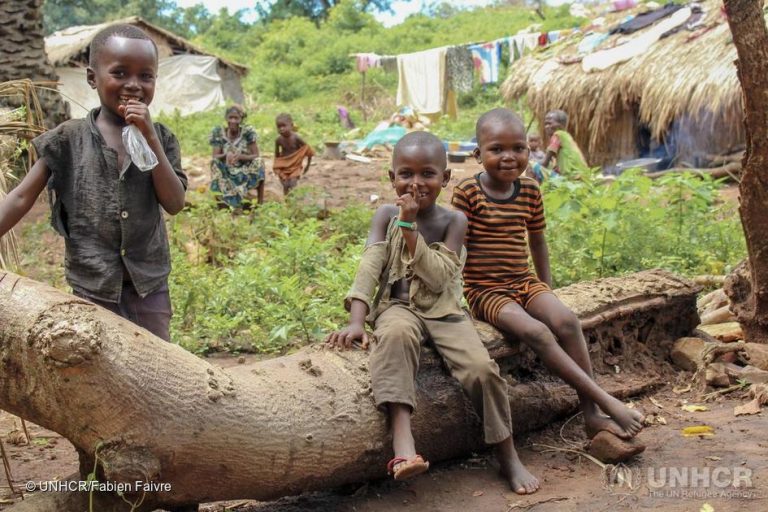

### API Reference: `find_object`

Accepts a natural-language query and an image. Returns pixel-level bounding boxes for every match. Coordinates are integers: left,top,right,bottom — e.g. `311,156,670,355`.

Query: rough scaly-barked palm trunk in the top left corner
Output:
0,0,69,128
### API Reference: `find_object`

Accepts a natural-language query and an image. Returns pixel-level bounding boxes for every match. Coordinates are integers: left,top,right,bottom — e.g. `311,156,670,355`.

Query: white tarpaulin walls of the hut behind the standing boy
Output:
56,55,225,118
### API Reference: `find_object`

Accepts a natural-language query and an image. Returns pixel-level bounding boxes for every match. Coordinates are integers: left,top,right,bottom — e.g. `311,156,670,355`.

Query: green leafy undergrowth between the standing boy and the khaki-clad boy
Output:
170,189,371,353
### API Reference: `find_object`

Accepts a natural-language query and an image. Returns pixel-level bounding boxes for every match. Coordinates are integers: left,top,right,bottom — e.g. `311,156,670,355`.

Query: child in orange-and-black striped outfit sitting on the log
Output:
452,108,643,448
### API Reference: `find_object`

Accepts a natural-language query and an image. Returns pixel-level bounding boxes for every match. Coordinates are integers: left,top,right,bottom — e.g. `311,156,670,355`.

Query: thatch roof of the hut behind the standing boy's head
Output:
45,16,248,75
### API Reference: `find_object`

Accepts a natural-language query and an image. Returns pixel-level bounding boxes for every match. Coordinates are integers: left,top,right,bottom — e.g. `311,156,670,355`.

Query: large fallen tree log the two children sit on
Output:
0,271,699,512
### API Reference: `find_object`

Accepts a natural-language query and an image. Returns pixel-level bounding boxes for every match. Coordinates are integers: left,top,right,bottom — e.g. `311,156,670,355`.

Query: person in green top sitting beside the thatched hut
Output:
541,110,591,178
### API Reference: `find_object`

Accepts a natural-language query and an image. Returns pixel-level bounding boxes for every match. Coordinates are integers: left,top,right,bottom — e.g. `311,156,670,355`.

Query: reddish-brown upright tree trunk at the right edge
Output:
725,0,768,343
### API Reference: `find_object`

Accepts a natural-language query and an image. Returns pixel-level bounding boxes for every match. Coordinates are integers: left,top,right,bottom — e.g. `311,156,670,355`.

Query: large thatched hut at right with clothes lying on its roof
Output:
502,0,745,165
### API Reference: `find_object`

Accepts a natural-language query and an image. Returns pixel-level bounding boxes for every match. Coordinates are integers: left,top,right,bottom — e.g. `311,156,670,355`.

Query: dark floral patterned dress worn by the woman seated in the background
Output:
210,125,264,208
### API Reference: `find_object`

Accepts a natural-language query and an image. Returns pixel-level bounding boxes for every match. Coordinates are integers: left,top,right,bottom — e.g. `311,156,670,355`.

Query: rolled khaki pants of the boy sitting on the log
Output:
369,304,512,444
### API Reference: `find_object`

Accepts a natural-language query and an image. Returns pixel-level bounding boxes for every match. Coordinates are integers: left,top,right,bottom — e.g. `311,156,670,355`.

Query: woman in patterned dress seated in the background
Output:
210,105,264,208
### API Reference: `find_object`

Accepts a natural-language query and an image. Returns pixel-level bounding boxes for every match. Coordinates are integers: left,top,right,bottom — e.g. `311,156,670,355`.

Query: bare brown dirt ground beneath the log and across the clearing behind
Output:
0,159,752,512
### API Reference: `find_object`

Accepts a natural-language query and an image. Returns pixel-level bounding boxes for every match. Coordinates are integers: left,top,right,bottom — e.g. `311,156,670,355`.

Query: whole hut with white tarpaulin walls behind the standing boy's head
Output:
45,17,247,118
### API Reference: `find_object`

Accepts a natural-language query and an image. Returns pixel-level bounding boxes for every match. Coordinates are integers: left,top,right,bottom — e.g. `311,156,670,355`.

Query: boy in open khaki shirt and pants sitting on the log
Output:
326,132,539,494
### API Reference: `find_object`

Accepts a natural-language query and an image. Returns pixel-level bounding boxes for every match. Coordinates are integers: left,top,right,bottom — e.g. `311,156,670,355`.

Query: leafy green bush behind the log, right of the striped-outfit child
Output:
543,171,746,286
